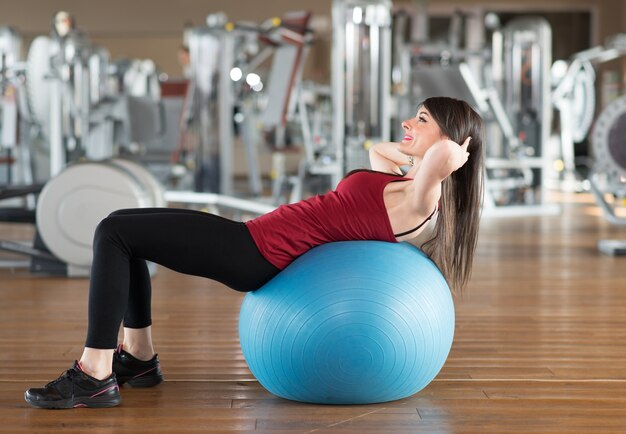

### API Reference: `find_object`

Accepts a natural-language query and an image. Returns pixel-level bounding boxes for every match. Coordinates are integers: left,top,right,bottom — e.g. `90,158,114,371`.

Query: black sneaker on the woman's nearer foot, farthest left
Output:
24,362,122,408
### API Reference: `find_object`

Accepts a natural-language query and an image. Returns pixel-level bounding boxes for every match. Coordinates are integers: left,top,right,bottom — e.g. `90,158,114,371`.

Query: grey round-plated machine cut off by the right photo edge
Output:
589,95,626,255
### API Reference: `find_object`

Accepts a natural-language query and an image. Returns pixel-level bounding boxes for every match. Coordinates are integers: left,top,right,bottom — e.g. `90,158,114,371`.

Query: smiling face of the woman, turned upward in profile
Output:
399,107,445,158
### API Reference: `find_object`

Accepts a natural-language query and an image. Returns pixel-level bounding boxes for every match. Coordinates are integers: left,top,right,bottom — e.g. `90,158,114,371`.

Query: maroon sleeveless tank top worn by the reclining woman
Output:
246,170,414,270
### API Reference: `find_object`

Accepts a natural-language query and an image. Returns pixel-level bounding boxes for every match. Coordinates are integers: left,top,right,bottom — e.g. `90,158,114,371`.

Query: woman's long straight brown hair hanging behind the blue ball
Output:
420,97,484,292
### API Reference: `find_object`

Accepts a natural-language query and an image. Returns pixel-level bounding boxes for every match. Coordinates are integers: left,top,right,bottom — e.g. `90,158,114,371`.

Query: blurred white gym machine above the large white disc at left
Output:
26,12,112,176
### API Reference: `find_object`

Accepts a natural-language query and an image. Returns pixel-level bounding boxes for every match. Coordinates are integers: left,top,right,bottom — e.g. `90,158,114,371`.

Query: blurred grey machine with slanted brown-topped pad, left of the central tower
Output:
177,12,311,197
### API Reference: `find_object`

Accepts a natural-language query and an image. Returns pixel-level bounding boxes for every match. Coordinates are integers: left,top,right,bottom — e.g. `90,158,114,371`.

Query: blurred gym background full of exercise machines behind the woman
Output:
0,0,626,274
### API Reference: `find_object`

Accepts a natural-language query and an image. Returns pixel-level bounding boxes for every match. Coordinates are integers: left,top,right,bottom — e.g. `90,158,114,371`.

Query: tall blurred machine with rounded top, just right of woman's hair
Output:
485,16,556,215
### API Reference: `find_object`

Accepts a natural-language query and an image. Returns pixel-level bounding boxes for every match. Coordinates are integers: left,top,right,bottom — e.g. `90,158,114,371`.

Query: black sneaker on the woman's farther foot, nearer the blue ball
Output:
113,345,163,387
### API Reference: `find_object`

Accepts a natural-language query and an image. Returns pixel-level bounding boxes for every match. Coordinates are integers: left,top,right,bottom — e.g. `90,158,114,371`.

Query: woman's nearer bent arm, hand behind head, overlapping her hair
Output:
413,137,471,215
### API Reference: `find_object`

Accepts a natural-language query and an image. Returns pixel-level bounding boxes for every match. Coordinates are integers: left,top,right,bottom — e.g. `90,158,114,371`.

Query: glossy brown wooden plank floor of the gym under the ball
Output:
0,195,626,434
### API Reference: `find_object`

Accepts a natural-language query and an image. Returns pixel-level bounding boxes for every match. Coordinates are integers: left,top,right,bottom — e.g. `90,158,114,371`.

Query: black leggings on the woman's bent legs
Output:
85,208,280,349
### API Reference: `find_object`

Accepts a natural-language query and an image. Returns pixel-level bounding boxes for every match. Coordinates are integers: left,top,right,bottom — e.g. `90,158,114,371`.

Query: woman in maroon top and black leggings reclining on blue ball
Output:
25,97,483,408
